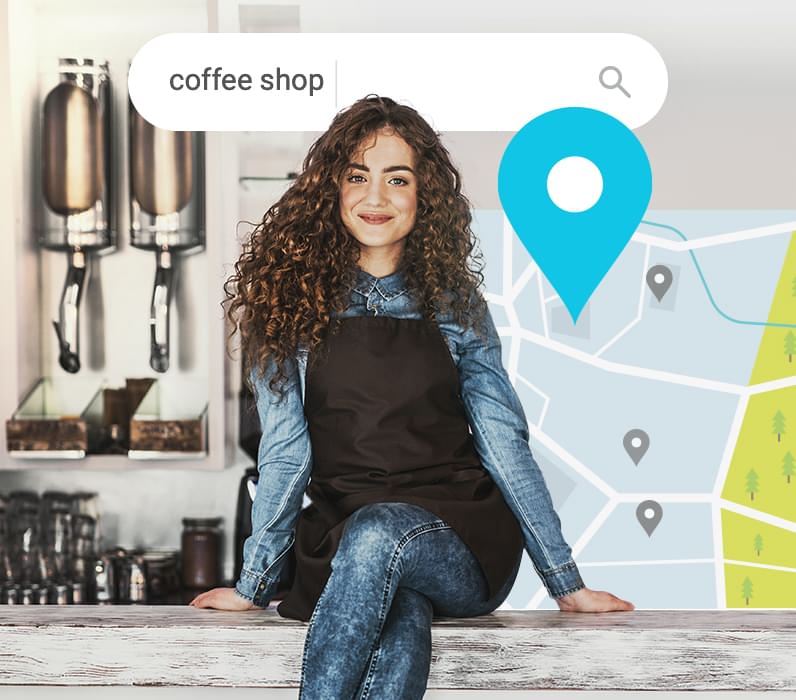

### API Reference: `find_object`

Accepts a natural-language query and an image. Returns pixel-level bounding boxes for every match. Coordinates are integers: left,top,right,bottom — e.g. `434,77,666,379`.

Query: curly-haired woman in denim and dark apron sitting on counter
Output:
191,96,633,700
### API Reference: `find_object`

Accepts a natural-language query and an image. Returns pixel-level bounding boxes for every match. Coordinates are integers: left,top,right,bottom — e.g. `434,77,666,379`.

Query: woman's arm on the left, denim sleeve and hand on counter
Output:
191,360,312,610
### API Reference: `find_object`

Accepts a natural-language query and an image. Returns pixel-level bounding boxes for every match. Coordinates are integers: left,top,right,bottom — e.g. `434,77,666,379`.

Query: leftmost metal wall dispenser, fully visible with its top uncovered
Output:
39,58,116,373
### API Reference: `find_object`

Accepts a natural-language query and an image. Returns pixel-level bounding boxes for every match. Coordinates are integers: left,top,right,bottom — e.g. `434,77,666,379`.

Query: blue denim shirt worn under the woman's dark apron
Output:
235,270,584,607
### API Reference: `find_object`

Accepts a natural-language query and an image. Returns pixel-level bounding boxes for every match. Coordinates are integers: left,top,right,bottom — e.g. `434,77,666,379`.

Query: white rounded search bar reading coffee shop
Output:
128,33,668,131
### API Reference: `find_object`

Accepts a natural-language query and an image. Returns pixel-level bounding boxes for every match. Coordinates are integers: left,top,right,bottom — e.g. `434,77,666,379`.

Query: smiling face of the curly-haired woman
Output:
340,127,417,274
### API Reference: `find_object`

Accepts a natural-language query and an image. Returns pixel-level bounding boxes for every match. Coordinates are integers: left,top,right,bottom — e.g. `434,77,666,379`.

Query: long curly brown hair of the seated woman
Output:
222,95,486,397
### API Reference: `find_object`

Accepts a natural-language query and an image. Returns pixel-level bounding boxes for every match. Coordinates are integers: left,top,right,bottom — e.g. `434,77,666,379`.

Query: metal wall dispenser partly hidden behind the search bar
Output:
128,100,204,372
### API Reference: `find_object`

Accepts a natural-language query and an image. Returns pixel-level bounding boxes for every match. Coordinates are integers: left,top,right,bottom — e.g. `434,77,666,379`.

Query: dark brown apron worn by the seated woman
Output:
277,316,522,621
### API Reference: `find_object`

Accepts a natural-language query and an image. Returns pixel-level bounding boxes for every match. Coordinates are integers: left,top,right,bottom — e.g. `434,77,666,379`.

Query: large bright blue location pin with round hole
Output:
498,107,652,322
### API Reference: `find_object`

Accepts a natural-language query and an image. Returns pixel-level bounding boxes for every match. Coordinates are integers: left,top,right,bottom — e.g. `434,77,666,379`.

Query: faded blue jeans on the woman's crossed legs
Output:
299,502,521,700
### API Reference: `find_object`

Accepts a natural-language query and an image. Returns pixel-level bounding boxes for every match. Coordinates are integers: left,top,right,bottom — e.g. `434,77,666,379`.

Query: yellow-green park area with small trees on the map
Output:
722,235,796,608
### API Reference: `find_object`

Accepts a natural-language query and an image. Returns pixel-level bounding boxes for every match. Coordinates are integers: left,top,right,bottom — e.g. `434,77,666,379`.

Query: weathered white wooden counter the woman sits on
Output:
0,605,796,691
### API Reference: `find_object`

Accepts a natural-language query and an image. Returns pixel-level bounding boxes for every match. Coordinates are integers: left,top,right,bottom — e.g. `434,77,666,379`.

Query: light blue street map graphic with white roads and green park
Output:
473,210,796,609
